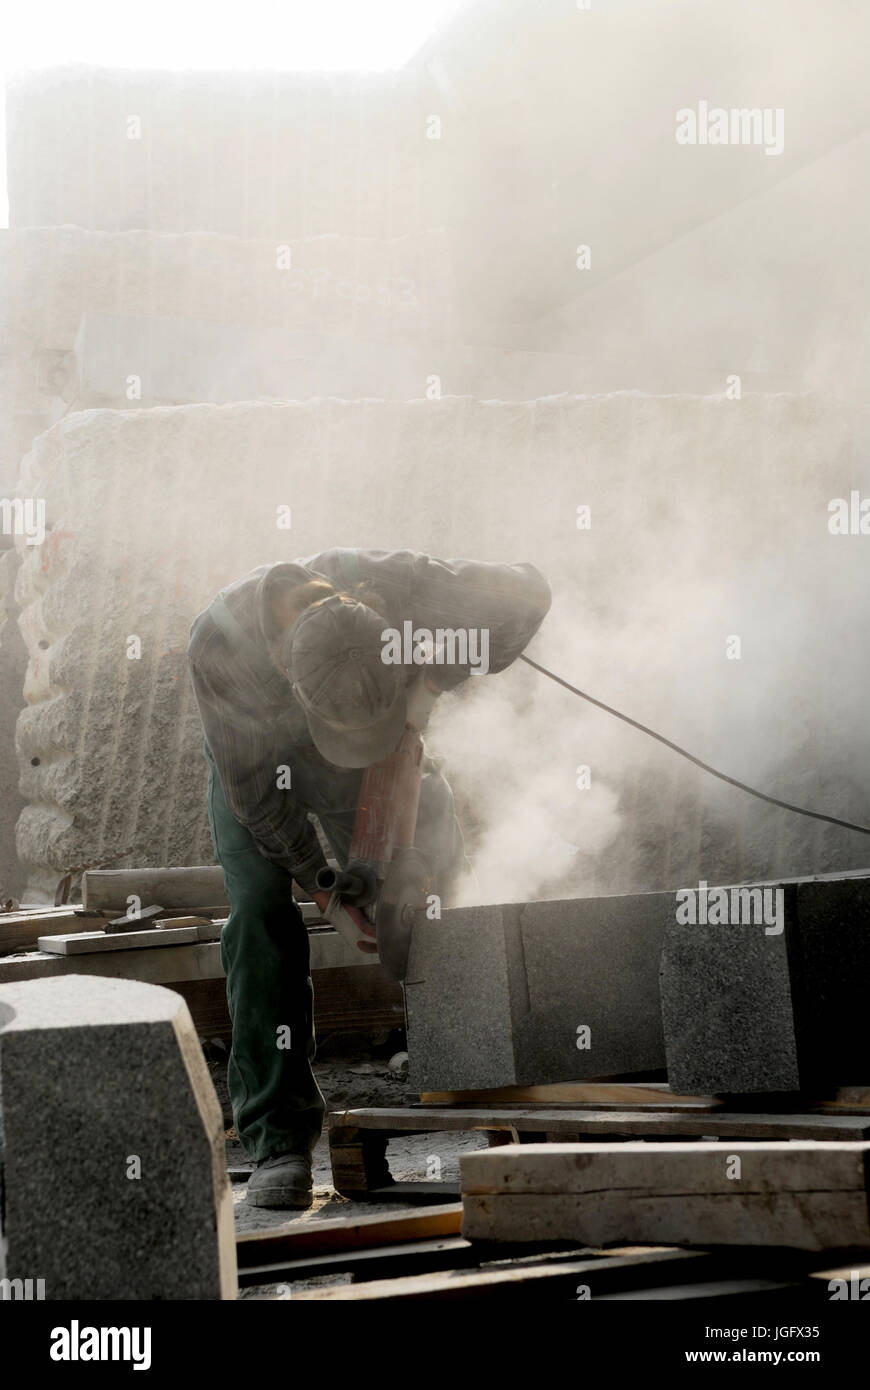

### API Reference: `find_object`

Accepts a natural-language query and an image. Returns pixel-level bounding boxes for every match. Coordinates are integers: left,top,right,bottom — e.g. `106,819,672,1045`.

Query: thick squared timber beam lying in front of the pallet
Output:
460,1143,870,1251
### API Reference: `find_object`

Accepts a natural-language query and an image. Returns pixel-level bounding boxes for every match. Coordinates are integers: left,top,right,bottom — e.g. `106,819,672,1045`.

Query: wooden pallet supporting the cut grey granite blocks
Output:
328,1105,870,1200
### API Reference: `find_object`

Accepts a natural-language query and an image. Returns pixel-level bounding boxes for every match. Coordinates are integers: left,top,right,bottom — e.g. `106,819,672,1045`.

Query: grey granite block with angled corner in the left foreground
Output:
0,976,236,1300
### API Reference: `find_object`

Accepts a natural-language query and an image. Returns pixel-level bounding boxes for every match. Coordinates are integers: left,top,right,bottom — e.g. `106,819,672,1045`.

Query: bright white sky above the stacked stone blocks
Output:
0,0,466,227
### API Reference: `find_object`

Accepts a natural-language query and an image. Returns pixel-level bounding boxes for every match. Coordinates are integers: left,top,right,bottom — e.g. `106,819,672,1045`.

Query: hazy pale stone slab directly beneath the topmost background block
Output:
0,227,456,461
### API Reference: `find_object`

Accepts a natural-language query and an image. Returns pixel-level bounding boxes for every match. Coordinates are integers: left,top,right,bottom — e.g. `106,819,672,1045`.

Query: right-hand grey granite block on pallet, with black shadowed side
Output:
662,877,870,1094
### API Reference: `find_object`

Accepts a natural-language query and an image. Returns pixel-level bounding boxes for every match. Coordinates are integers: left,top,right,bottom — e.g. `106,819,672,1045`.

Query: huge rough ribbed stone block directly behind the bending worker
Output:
15,393,870,897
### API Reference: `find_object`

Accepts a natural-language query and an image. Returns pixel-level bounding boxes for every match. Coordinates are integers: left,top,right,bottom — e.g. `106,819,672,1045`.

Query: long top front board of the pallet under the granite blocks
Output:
329,1105,870,1140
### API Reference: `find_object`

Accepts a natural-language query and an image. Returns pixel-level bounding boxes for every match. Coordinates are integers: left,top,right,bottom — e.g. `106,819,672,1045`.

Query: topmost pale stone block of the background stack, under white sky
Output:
2,67,430,239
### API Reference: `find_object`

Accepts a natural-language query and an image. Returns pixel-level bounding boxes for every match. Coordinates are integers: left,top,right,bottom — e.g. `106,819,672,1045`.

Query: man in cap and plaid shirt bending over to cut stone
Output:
189,549,550,1208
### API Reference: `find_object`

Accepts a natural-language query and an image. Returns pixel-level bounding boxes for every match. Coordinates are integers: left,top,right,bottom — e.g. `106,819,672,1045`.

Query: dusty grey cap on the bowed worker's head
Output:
285,595,406,767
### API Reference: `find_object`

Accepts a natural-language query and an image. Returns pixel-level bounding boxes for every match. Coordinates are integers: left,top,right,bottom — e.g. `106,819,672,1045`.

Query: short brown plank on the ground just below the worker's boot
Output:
230,1202,463,1269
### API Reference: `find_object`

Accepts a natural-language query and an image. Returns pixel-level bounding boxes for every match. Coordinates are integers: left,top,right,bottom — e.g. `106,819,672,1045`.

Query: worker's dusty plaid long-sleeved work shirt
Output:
188,549,550,891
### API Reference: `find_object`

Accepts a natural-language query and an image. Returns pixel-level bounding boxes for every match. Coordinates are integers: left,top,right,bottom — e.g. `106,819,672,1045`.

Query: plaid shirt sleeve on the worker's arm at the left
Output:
189,631,327,892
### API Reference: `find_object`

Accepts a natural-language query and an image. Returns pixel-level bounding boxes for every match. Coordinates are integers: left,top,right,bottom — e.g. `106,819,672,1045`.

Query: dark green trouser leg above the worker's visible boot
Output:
208,766,325,1159
